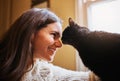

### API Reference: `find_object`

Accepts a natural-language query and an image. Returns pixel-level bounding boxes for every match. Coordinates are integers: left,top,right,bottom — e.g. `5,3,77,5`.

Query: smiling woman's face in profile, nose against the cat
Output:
32,22,62,61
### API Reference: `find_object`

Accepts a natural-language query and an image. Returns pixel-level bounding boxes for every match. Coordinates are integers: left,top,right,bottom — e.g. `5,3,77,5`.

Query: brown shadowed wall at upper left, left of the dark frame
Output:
0,0,31,38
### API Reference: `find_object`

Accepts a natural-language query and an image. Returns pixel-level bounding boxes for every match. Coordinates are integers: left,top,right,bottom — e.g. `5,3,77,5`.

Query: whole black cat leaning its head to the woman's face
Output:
62,18,120,81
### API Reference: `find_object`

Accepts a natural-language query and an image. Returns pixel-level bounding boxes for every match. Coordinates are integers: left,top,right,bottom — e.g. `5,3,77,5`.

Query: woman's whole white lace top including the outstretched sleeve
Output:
21,60,89,81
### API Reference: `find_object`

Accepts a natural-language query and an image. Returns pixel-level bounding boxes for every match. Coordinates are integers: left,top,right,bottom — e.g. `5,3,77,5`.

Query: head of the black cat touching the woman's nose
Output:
61,18,89,45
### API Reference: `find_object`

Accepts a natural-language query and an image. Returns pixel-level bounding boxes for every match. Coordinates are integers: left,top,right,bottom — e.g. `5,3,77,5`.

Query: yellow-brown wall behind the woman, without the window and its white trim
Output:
0,0,76,70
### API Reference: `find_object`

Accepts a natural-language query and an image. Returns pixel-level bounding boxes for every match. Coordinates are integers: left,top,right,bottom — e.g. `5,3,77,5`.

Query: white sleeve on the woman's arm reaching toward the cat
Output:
49,65,90,81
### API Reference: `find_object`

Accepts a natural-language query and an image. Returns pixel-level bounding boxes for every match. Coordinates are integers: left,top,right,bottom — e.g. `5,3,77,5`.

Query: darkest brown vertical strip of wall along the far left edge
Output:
0,0,11,38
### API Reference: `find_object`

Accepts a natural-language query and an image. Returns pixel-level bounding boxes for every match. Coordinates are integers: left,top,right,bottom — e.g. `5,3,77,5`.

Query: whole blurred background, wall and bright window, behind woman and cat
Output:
0,0,120,71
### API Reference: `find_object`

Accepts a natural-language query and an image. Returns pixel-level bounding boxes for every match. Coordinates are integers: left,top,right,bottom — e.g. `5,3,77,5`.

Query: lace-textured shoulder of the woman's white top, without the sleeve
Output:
21,60,54,81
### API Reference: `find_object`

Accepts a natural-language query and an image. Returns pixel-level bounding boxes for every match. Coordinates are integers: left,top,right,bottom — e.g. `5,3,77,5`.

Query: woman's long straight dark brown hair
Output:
0,8,61,81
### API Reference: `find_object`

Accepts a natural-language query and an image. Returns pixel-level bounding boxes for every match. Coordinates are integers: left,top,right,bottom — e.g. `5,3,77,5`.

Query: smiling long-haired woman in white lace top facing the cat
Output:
0,8,89,81
